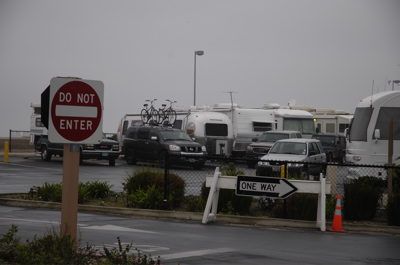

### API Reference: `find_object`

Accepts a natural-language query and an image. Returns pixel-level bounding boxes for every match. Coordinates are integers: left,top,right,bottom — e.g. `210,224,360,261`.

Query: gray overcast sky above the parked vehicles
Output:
0,0,400,137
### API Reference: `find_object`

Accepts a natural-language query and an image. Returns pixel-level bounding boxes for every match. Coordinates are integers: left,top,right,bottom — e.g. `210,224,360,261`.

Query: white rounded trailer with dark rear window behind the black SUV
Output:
178,111,234,156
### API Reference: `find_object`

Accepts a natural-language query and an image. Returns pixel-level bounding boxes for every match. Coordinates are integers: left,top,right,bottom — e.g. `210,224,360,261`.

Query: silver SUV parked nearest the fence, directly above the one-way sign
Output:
256,138,326,179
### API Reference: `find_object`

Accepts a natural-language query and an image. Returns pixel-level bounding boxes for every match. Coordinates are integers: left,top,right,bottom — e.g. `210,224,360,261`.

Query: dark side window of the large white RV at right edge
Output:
375,107,400,140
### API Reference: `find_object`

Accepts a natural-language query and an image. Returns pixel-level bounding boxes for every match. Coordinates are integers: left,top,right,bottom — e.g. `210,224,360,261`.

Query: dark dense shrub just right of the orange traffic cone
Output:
343,176,387,220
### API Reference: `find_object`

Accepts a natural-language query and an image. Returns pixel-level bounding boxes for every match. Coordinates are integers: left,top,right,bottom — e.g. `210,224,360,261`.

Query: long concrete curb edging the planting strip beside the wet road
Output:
0,198,400,236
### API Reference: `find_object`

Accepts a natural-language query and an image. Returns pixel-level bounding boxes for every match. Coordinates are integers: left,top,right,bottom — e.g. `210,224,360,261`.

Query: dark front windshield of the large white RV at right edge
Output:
349,108,374,142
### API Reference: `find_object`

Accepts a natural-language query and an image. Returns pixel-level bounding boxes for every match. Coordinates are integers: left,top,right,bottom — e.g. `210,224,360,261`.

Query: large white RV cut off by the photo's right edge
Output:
346,91,400,177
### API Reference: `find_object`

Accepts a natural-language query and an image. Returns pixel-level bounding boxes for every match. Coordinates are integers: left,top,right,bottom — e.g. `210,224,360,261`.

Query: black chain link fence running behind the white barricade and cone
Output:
161,157,400,225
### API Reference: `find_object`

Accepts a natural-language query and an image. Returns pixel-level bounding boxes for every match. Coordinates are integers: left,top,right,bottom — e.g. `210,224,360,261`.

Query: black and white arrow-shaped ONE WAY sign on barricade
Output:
236,176,297,199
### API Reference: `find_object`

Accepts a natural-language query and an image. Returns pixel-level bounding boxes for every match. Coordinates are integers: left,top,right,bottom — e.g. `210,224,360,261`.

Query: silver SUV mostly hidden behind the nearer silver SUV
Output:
246,131,303,168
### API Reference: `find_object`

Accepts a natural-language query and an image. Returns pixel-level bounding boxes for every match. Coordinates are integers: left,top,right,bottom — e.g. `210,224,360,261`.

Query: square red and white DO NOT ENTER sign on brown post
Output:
49,77,104,143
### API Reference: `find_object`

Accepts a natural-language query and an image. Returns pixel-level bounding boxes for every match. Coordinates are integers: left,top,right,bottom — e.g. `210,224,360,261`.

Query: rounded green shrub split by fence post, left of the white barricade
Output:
122,167,185,209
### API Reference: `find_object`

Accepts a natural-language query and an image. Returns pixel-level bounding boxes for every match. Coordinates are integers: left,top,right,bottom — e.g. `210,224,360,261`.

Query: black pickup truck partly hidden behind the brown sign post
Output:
35,135,121,166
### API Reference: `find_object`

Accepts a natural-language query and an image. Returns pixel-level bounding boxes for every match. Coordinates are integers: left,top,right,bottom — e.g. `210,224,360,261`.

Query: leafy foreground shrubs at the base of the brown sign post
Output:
0,225,159,265
